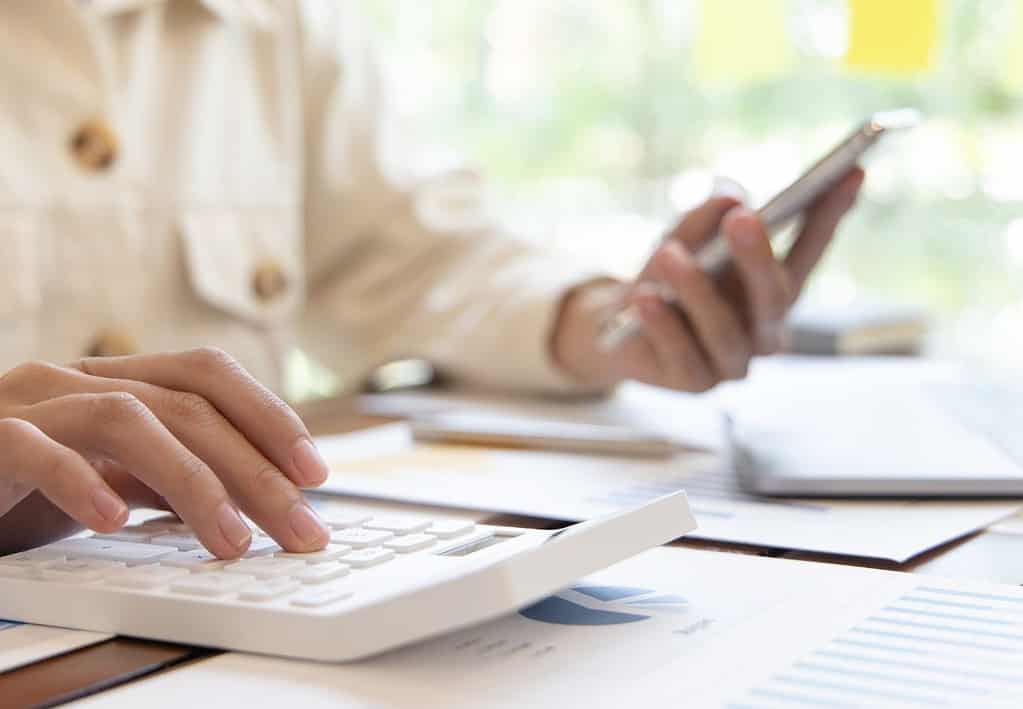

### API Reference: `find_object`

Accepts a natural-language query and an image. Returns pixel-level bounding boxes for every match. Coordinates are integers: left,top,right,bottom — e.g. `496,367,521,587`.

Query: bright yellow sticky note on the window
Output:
845,0,940,74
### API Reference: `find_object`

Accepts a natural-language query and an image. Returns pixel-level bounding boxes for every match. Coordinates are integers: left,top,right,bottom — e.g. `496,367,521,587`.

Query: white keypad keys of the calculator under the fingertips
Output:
0,511,476,610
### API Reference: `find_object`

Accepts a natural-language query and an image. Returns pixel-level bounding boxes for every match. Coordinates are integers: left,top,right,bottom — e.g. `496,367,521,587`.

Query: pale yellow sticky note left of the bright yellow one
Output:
693,0,792,83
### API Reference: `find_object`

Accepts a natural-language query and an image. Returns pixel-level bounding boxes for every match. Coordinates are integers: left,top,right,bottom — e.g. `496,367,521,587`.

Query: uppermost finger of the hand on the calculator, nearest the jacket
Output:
74,348,328,487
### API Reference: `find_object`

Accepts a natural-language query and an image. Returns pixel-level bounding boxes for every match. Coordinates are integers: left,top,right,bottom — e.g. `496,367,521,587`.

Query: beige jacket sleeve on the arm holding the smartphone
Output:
292,1,598,393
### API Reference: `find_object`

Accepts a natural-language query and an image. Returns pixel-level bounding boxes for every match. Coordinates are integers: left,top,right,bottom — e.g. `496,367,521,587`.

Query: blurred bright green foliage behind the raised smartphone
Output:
364,0,1023,370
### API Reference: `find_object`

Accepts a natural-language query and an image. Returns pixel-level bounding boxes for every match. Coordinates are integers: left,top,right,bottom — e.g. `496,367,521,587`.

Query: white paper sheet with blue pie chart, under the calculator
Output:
75,547,1023,709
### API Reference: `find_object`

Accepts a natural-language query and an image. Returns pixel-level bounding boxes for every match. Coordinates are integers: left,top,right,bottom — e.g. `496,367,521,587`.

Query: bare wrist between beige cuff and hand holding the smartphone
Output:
550,277,628,389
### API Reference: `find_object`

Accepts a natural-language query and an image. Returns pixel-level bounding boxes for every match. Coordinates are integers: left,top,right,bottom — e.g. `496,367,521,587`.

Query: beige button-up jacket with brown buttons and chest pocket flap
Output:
0,0,587,390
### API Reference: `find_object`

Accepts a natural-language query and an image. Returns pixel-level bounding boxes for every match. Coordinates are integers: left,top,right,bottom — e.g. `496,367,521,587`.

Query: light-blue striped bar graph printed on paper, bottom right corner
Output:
731,585,1023,708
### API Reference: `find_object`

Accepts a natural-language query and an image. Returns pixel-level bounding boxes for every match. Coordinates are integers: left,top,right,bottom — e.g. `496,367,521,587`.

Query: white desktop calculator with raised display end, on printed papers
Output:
0,492,696,662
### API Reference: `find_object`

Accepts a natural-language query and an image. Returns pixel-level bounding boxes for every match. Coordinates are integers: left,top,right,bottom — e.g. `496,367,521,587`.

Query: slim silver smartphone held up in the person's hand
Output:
598,108,920,350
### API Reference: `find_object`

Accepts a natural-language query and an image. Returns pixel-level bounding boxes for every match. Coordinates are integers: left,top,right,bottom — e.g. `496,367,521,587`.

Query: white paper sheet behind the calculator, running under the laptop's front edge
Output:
318,417,1019,563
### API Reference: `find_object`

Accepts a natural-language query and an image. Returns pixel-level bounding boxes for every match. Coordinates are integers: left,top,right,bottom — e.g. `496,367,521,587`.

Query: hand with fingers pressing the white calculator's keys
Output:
0,348,328,559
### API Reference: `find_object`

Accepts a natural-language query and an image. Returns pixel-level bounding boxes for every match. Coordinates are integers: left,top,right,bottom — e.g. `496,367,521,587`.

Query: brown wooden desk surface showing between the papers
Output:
0,399,1023,707
